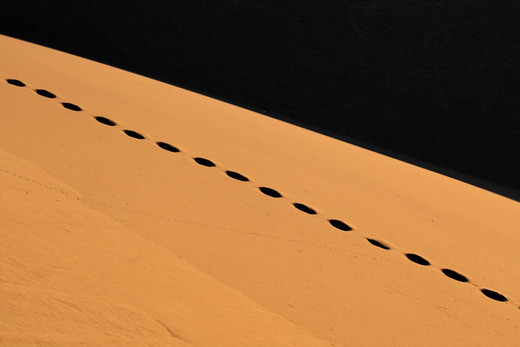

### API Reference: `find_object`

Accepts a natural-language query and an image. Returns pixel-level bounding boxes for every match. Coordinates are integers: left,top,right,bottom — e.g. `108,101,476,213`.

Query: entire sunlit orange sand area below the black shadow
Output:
0,37,520,345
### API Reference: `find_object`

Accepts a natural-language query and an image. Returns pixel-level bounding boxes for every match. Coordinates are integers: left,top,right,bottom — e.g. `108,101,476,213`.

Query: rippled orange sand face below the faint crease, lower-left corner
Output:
0,152,330,346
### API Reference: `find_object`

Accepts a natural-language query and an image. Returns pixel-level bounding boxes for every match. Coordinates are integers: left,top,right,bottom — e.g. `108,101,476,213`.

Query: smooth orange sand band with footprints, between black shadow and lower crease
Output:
0,37,520,345
